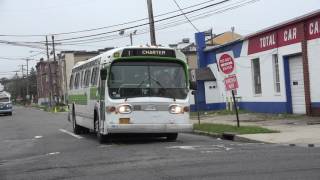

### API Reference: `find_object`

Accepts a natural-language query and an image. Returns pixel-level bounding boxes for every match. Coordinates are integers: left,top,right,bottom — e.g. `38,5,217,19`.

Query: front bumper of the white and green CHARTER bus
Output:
107,124,193,133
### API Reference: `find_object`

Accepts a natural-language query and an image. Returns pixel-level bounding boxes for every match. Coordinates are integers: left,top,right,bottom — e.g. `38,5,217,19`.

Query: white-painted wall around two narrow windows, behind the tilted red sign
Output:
205,41,304,103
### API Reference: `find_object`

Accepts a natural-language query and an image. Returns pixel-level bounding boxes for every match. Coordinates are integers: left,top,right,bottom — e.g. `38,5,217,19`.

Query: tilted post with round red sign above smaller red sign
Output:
217,51,240,127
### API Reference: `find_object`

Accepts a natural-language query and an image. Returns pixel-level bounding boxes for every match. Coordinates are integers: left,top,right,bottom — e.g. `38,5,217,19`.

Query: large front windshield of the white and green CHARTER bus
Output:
108,61,188,99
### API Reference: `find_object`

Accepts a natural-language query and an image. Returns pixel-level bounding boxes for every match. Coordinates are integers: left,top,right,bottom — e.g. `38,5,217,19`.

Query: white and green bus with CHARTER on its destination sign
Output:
68,47,192,142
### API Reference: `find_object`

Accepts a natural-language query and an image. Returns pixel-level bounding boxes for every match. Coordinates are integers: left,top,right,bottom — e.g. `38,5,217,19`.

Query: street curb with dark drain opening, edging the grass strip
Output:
191,130,269,144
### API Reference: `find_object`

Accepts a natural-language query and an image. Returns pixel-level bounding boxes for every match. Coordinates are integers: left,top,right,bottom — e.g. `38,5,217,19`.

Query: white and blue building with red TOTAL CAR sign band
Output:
192,11,320,115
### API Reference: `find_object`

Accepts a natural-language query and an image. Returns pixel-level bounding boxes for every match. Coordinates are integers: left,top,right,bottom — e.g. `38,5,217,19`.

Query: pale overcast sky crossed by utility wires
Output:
0,0,320,77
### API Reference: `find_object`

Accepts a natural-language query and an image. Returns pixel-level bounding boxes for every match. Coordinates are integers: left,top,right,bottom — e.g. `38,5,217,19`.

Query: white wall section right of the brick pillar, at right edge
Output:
308,38,320,102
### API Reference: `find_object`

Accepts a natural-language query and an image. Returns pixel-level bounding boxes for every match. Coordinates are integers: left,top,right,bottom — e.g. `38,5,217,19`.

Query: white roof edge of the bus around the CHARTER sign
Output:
73,46,186,69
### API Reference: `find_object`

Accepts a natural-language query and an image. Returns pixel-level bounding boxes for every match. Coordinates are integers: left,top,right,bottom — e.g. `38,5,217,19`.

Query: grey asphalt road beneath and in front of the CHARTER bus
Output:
0,107,320,180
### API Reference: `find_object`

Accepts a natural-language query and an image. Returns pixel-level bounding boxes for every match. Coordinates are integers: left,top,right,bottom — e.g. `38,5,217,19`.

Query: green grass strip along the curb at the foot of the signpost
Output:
193,123,278,134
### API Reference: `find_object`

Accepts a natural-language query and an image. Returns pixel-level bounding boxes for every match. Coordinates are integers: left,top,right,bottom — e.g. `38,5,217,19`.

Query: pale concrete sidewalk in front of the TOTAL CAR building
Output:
192,113,320,147
